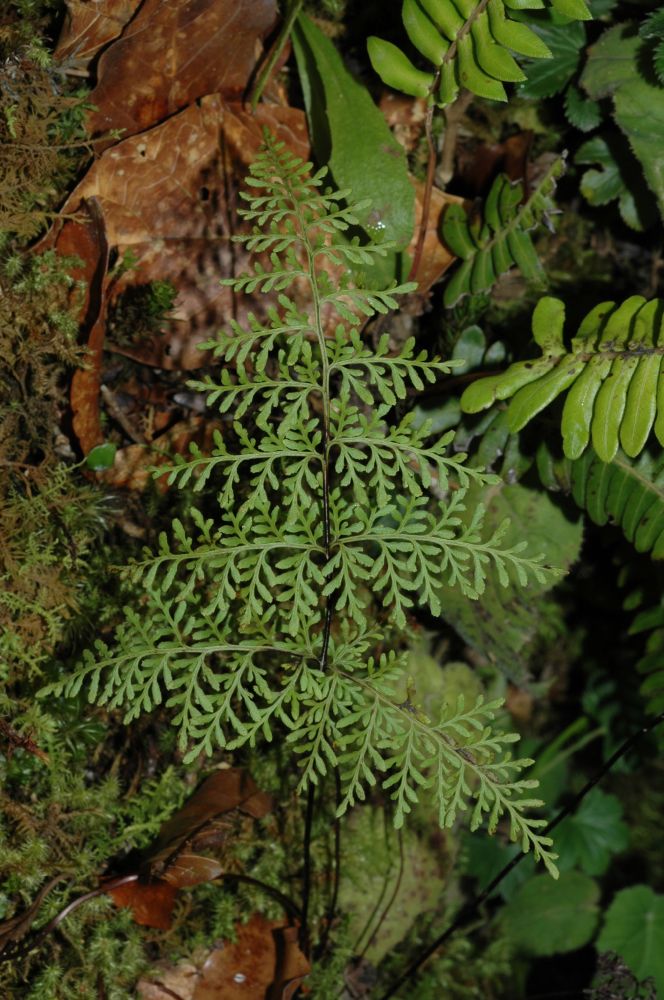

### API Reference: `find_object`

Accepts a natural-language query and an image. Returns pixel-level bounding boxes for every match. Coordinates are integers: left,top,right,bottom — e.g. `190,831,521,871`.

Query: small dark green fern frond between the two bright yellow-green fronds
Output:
443,159,564,309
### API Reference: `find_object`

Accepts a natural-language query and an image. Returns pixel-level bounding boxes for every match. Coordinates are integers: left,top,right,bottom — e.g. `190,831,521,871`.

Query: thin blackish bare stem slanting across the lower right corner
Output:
379,712,664,1000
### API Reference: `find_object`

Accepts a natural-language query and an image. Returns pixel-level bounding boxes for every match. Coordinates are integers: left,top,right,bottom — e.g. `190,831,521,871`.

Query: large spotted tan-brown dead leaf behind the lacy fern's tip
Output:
59,95,309,370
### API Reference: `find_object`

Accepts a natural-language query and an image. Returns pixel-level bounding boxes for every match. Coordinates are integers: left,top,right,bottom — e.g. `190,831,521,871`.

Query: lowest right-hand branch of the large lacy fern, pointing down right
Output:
322,656,556,874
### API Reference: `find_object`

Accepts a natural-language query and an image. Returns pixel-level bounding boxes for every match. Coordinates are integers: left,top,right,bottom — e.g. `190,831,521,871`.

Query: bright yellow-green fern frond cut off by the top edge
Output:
367,0,592,107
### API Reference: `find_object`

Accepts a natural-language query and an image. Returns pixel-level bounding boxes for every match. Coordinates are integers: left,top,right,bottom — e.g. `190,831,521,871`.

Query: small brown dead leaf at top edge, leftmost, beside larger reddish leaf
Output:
53,0,141,70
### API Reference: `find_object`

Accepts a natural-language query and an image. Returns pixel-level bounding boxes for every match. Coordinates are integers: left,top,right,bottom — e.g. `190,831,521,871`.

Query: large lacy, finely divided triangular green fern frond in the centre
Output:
42,136,555,872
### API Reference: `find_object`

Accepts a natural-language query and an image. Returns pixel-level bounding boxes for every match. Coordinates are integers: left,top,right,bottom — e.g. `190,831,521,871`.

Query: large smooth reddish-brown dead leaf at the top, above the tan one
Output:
89,0,277,142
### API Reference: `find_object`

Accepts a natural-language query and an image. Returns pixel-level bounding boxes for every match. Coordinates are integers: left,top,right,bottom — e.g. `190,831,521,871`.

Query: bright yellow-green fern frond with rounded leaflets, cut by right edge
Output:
461,295,664,462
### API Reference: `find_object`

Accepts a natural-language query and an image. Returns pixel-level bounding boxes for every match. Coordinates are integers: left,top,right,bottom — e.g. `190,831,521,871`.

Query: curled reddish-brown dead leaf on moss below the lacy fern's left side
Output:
101,767,272,930
